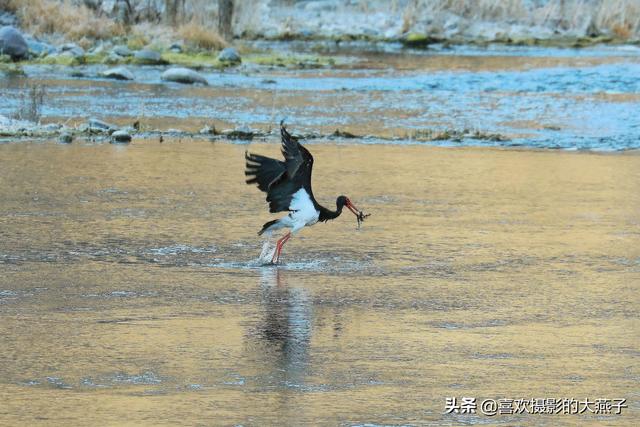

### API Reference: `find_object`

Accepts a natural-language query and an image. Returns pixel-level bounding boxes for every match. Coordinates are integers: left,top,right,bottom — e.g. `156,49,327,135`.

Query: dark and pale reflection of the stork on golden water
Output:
256,268,313,386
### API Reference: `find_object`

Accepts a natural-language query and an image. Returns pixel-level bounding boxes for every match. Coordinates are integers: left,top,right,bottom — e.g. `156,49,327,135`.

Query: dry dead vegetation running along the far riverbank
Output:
0,0,640,45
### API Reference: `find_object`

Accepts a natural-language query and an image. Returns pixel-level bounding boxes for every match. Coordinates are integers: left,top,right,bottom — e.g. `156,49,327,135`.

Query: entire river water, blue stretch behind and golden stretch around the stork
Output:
0,47,640,426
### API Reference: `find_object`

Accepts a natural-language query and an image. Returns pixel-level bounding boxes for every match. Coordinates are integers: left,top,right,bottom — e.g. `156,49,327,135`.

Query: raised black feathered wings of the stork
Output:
245,122,313,213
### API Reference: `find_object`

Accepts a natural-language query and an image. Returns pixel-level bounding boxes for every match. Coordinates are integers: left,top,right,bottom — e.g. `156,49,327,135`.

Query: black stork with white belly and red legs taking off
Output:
245,122,368,264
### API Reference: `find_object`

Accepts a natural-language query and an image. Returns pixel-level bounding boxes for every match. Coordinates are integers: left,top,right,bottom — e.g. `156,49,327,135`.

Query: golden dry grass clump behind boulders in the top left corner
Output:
3,0,124,40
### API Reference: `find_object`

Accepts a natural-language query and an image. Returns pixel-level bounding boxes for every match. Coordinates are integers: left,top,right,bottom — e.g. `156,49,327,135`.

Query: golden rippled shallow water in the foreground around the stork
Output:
0,139,640,426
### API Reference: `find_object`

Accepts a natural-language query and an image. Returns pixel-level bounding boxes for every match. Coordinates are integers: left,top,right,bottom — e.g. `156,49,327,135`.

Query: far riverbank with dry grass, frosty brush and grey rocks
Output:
0,0,640,68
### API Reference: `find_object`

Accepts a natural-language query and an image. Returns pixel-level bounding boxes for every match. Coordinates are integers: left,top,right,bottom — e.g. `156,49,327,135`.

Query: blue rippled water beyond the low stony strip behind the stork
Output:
0,44,640,151
